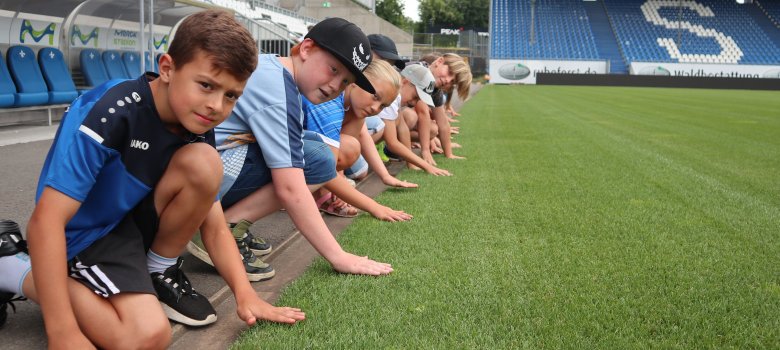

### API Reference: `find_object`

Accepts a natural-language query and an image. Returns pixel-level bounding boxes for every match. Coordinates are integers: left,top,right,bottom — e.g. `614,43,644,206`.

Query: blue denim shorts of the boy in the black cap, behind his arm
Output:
222,139,336,209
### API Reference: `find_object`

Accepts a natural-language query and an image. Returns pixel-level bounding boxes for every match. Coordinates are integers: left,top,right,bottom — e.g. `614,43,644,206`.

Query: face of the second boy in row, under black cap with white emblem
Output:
295,46,355,104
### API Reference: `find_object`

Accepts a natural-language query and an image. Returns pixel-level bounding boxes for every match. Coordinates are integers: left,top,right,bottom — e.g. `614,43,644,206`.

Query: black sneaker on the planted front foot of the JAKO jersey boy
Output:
152,258,217,326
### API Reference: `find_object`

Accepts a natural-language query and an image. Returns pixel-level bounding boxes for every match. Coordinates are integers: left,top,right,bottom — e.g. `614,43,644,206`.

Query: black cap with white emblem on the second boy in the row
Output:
304,17,376,94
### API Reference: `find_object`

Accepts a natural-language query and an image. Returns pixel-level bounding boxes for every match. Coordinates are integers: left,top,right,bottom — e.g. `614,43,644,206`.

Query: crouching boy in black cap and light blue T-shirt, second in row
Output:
187,17,392,280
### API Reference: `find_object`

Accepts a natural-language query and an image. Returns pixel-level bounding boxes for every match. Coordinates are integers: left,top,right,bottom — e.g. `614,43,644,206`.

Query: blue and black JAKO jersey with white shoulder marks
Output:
36,76,214,260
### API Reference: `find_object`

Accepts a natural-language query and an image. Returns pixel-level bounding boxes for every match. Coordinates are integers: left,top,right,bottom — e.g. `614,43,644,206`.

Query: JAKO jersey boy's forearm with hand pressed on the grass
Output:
200,201,306,326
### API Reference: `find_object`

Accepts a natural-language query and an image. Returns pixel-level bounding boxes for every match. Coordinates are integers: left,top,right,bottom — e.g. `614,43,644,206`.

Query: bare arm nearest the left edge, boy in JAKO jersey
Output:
27,187,94,349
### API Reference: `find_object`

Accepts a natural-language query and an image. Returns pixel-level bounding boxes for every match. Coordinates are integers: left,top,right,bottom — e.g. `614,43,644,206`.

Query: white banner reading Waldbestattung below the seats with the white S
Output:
631,62,780,79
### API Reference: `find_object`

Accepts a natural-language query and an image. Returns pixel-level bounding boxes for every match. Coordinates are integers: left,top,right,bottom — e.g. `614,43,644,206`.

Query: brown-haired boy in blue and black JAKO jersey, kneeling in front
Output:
0,10,304,348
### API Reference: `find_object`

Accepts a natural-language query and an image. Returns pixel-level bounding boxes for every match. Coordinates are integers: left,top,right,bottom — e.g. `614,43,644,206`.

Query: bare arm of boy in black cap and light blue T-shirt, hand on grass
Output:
271,168,393,275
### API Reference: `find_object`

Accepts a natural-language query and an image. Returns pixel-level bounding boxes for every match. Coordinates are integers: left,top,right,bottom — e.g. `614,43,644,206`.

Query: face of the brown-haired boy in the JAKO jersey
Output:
165,52,246,134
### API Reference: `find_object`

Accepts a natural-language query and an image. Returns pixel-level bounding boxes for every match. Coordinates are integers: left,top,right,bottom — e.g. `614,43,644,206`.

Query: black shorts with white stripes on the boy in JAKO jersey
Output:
68,196,160,297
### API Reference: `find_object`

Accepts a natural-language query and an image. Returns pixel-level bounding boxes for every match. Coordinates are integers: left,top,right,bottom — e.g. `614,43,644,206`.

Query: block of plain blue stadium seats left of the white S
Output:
491,0,599,59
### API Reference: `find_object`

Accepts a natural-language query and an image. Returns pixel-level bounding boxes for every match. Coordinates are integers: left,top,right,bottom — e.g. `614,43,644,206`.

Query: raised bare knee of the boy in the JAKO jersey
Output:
168,143,222,193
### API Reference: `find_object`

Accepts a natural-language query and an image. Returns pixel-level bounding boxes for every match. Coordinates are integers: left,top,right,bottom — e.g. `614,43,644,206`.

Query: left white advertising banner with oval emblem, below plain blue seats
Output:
490,59,607,84
